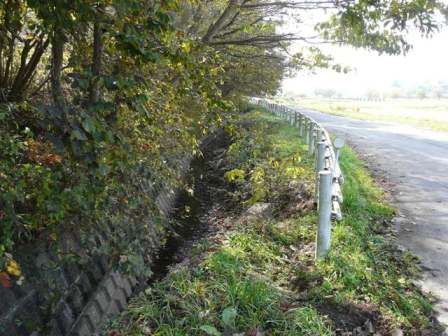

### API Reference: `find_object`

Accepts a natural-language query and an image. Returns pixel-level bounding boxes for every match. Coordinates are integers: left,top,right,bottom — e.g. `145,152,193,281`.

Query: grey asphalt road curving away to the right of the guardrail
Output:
298,109,448,324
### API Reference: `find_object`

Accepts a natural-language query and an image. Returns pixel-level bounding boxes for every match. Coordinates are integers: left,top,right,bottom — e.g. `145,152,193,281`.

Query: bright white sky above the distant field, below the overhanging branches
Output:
283,24,448,95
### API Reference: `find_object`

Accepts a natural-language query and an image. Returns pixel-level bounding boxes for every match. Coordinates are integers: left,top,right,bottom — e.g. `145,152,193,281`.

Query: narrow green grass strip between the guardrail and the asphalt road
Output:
322,147,431,329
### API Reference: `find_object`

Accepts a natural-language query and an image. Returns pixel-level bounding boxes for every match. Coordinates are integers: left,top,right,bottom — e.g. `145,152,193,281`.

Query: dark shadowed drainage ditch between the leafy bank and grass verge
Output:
149,130,235,283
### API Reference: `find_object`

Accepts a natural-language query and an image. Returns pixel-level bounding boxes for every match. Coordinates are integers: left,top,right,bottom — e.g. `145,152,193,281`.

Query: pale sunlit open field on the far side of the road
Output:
285,98,448,132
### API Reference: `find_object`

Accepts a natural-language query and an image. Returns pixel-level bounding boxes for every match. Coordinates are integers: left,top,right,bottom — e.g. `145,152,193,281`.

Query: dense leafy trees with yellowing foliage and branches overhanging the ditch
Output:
0,0,443,280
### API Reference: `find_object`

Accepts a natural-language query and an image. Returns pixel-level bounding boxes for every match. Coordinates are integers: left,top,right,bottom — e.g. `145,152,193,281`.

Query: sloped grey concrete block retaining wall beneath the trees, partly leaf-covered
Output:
0,132,219,336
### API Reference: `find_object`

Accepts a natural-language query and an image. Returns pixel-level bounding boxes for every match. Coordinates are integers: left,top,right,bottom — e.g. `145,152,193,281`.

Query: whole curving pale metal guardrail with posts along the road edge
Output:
252,98,344,259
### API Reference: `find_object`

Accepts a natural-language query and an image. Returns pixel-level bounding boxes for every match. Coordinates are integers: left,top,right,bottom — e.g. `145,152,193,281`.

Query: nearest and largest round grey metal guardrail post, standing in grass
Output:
316,170,332,259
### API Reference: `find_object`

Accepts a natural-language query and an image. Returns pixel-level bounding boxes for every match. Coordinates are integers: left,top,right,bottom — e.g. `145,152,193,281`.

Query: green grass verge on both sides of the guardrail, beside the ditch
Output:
108,111,438,336
